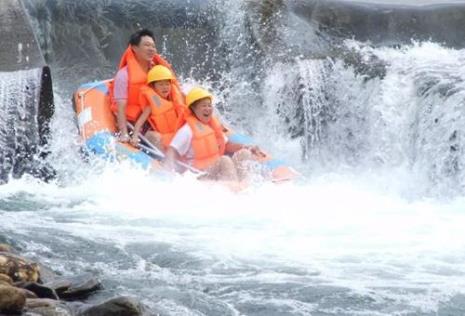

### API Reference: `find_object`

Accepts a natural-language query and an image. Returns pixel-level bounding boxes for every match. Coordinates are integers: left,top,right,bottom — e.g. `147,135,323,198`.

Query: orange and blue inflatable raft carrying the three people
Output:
73,80,298,182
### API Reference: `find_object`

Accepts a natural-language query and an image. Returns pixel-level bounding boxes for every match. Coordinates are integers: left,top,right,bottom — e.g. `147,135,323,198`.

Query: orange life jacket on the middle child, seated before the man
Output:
139,84,187,148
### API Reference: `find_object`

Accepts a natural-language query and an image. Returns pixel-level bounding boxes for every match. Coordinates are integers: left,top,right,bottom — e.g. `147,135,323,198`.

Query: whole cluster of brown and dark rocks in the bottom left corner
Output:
0,244,144,316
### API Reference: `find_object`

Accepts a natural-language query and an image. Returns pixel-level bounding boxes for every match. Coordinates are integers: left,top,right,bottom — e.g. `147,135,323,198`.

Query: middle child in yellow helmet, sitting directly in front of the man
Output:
131,65,186,150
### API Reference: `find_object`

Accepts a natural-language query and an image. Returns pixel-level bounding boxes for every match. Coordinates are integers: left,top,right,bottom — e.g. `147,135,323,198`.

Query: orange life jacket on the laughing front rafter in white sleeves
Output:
185,113,225,169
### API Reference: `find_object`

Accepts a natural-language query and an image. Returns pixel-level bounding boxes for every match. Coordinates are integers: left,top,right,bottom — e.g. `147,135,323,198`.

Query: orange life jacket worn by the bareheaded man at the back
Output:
110,45,185,122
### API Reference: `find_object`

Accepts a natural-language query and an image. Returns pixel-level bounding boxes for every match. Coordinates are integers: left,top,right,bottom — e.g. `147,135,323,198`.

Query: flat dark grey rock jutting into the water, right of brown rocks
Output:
44,273,101,299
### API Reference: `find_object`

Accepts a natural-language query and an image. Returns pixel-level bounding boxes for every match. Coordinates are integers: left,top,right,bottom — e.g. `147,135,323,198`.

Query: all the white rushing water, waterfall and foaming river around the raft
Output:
0,1,465,315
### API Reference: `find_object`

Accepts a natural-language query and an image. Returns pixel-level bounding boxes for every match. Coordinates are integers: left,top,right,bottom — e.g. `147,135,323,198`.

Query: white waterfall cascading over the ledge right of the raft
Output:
261,41,465,195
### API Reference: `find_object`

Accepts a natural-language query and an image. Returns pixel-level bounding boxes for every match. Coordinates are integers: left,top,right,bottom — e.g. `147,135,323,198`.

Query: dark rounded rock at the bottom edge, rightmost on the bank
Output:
78,296,143,316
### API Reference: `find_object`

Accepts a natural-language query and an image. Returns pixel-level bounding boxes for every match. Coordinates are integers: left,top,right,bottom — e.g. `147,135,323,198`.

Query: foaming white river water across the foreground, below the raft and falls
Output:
4,159,465,315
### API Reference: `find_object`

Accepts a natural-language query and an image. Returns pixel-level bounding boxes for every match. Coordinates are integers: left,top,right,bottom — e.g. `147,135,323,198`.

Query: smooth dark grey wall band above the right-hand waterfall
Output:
289,0,465,47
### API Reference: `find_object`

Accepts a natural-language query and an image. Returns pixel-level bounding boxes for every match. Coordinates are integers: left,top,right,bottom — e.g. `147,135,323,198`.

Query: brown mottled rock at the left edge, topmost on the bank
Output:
0,252,40,282
